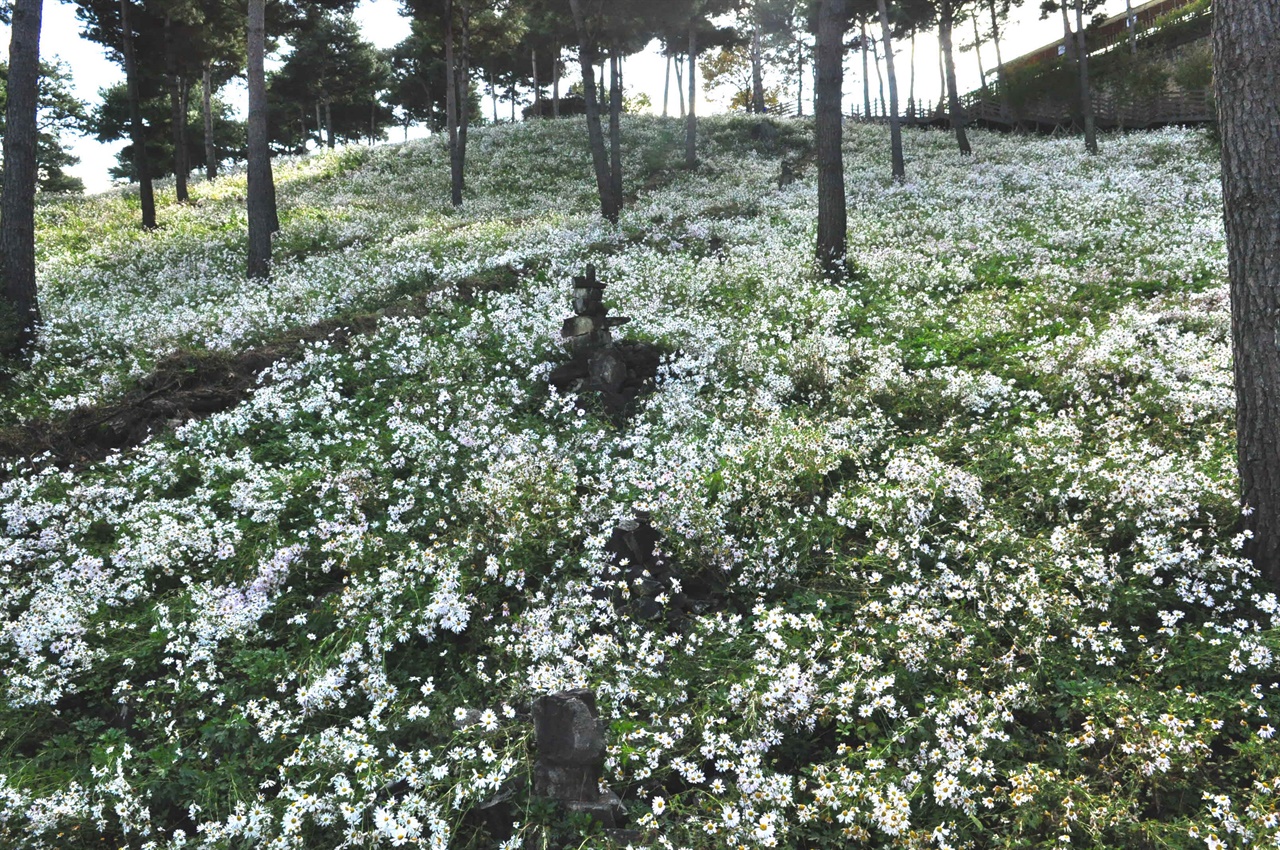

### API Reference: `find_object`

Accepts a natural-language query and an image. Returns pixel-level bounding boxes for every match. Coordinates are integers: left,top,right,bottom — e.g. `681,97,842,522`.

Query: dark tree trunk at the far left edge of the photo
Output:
0,0,42,355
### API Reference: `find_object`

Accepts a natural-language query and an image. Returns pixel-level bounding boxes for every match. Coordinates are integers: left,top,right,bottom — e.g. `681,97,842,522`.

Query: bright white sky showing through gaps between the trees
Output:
12,0,1124,192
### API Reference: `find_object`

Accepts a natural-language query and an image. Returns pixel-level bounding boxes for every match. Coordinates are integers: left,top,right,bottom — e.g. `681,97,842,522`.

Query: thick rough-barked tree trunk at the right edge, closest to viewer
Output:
1213,0,1280,583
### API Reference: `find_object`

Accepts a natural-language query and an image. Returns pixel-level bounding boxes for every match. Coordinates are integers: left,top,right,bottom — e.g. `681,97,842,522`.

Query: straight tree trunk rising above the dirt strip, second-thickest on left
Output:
247,0,276,279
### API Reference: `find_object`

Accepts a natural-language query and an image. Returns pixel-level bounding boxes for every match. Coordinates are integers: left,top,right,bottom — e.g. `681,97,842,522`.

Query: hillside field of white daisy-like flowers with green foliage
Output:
0,119,1280,850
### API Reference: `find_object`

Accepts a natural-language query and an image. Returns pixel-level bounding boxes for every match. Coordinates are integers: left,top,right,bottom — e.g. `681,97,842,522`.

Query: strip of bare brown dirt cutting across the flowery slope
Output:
0,273,518,481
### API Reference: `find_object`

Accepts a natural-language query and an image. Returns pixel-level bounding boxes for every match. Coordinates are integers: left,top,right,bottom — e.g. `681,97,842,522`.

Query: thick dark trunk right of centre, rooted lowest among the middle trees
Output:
814,0,849,280
